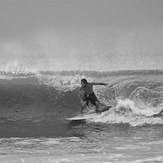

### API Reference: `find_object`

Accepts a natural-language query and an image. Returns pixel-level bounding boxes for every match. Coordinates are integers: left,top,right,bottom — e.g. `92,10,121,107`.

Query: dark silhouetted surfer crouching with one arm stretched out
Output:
80,79,107,112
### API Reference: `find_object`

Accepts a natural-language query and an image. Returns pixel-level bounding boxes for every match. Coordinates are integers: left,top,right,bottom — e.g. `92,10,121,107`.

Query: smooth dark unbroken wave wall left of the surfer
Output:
0,77,80,121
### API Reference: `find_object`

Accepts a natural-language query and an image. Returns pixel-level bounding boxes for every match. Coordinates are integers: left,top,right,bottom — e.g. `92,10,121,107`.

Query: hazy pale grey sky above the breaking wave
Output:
0,0,163,71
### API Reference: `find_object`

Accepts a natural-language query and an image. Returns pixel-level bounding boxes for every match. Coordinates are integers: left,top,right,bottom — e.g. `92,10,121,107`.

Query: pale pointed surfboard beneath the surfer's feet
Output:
66,106,111,121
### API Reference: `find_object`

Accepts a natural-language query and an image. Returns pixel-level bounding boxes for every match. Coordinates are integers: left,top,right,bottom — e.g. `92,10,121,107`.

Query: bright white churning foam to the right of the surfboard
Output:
89,99,163,126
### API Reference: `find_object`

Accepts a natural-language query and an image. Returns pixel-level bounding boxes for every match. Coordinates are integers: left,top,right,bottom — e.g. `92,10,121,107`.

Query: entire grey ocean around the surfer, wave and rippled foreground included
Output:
0,70,163,163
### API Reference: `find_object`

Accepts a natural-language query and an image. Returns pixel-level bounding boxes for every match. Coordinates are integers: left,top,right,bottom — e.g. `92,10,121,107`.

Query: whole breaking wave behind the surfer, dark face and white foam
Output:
0,71,163,130
